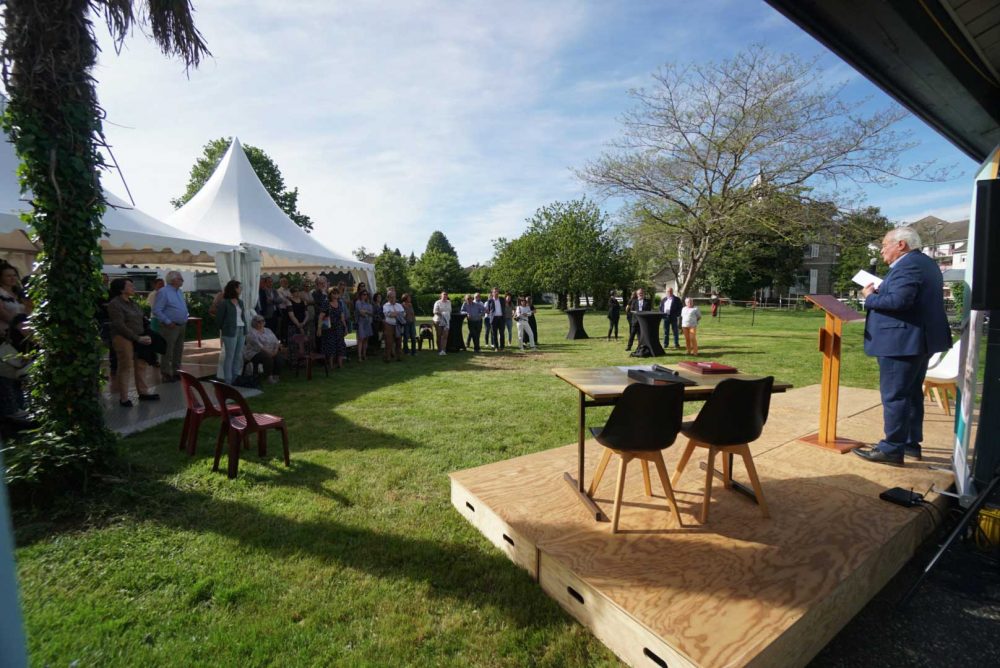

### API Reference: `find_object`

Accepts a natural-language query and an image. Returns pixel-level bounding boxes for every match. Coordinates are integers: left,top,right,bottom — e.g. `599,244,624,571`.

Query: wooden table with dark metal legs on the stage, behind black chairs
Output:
552,364,792,521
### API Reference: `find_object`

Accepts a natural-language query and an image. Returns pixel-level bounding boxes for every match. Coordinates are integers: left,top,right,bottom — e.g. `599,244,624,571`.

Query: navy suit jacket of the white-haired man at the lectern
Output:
865,251,951,357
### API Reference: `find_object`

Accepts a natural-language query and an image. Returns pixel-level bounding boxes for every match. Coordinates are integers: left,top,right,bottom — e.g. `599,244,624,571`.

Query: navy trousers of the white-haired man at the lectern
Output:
877,355,929,455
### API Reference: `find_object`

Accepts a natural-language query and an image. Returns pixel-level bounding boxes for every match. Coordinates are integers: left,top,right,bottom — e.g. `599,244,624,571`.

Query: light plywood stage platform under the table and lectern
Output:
451,385,953,668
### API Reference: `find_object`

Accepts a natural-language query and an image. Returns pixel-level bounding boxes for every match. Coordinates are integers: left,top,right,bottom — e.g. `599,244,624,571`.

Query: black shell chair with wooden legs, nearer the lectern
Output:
671,376,774,524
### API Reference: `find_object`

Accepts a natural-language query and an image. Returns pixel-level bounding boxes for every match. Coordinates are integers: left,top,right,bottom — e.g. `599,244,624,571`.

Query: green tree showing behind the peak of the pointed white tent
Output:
170,137,313,232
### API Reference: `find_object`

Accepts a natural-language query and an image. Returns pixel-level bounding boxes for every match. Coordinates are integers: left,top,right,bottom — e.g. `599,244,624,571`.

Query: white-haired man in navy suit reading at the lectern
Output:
854,227,951,466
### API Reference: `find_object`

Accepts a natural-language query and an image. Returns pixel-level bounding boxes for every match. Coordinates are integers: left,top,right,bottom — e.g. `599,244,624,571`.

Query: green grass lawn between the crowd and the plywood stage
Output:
15,308,877,666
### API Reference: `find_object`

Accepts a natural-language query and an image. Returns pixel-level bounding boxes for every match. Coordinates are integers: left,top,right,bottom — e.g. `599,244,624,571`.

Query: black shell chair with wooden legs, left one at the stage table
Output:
588,383,684,533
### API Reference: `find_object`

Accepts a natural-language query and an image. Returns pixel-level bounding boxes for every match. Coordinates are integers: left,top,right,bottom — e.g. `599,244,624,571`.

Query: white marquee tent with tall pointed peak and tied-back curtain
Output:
167,139,375,308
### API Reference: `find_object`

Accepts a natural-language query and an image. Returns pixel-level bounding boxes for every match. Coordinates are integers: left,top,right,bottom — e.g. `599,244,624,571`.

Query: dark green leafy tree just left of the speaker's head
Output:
831,206,893,294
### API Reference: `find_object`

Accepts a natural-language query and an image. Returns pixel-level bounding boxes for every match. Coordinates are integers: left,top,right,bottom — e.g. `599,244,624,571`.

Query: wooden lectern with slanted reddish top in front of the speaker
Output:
801,295,865,454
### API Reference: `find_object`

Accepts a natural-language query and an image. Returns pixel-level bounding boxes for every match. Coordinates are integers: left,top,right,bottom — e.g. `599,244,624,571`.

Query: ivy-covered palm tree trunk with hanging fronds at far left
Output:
0,0,209,479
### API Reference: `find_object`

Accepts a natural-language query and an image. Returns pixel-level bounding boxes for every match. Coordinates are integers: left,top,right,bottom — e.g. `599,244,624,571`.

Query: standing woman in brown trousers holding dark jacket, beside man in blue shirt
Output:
108,278,160,408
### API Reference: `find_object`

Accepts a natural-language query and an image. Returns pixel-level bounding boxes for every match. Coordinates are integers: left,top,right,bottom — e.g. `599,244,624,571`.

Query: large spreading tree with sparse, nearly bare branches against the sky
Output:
579,46,940,293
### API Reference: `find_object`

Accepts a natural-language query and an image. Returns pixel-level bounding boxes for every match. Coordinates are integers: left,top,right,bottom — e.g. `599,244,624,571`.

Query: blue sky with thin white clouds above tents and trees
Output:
95,0,975,264
